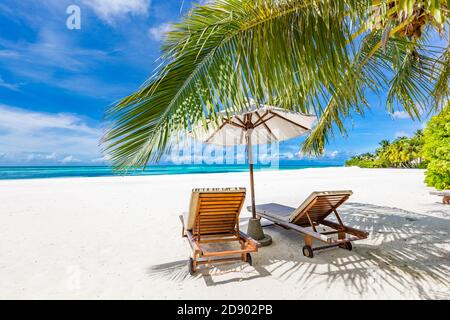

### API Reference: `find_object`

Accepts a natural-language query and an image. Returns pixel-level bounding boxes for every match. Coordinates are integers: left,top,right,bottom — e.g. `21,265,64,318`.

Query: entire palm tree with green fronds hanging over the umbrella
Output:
102,0,450,168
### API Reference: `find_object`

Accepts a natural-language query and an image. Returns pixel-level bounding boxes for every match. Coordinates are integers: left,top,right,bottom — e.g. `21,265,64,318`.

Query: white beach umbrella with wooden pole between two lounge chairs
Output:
191,105,317,218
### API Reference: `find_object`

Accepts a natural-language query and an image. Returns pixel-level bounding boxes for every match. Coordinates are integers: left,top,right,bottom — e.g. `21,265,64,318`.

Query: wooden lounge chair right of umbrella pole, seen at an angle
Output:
248,191,368,258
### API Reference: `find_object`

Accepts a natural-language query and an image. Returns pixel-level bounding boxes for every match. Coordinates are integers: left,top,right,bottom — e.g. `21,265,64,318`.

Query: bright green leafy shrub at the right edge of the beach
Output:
423,101,450,190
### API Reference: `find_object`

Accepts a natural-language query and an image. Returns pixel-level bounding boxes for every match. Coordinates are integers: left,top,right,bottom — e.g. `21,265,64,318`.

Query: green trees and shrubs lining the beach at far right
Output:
345,102,450,190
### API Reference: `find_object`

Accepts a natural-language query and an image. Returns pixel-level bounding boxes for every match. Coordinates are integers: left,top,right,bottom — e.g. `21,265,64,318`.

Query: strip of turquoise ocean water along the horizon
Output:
0,163,340,180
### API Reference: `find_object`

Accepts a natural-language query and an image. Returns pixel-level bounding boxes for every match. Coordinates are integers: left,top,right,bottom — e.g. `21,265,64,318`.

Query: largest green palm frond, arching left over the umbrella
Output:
103,0,369,167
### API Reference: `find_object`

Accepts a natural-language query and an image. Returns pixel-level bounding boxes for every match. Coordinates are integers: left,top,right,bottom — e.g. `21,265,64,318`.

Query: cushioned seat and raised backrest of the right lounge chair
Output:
256,190,353,225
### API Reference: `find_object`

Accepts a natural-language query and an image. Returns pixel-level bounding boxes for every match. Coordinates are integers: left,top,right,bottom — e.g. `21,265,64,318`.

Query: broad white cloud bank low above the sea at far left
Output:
0,104,102,162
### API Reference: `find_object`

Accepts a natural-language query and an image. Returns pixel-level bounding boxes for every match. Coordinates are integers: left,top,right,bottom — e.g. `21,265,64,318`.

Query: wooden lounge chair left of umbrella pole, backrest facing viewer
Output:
180,188,258,275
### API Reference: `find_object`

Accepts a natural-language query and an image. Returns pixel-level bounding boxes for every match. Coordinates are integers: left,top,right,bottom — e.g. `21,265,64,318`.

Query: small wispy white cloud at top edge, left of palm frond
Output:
83,0,150,25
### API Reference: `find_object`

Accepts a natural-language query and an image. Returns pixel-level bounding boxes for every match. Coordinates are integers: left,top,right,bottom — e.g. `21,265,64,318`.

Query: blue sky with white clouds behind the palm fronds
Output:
0,0,432,165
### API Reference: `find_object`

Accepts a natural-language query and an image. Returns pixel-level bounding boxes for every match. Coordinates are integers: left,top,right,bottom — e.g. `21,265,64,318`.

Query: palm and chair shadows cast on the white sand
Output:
147,203,450,299
